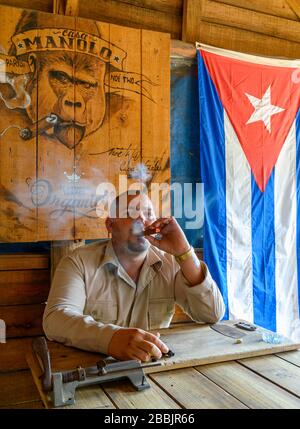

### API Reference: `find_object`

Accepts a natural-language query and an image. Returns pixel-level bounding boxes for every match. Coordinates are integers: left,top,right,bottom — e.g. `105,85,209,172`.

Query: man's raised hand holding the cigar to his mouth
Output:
145,217,190,256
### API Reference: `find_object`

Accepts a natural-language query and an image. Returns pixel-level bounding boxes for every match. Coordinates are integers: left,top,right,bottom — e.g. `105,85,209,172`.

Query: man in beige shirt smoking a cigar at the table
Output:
43,193,224,362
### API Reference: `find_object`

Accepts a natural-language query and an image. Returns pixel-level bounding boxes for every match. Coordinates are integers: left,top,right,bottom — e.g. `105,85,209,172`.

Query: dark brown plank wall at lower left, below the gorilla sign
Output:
0,254,50,408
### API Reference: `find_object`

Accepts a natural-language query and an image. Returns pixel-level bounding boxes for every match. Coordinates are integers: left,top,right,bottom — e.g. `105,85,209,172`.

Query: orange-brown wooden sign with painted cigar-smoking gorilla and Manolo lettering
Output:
0,6,170,242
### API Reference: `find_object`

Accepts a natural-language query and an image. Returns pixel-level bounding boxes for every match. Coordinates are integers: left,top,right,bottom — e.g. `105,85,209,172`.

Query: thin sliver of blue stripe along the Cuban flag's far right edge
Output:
296,110,300,317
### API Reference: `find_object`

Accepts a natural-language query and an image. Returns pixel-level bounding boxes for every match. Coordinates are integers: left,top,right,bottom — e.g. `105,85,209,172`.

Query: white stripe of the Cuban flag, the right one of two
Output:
274,118,299,339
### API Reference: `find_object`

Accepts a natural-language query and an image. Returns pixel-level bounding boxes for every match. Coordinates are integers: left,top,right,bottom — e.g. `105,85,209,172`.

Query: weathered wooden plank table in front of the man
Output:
27,322,300,409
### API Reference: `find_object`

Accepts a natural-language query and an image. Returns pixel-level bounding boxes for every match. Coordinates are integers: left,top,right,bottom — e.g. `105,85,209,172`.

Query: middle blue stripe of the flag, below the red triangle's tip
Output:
252,169,276,331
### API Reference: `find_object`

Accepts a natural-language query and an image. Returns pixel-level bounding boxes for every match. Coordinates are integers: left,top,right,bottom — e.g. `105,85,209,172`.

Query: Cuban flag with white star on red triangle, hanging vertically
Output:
197,44,300,340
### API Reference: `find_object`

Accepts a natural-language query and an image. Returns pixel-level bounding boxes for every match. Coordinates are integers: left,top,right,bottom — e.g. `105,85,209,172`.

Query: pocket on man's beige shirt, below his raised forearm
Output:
148,298,175,329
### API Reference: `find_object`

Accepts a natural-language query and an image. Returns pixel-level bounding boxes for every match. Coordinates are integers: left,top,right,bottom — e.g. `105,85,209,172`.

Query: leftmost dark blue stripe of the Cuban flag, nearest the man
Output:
197,51,229,319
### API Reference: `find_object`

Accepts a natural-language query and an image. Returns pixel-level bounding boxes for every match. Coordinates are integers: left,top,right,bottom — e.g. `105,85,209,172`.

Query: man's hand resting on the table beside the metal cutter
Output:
108,328,169,362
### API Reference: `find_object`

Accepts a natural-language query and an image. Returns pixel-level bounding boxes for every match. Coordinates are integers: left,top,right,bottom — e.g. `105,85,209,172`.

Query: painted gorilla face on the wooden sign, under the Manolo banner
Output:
27,52,106,149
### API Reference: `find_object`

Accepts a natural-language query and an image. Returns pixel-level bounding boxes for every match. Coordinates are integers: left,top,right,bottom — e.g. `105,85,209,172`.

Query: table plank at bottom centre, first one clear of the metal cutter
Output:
151,368,247,409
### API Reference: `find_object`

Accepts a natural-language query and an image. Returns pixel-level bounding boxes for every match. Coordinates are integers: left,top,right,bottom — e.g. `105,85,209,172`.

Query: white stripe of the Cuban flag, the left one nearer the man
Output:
224,111,253,322
